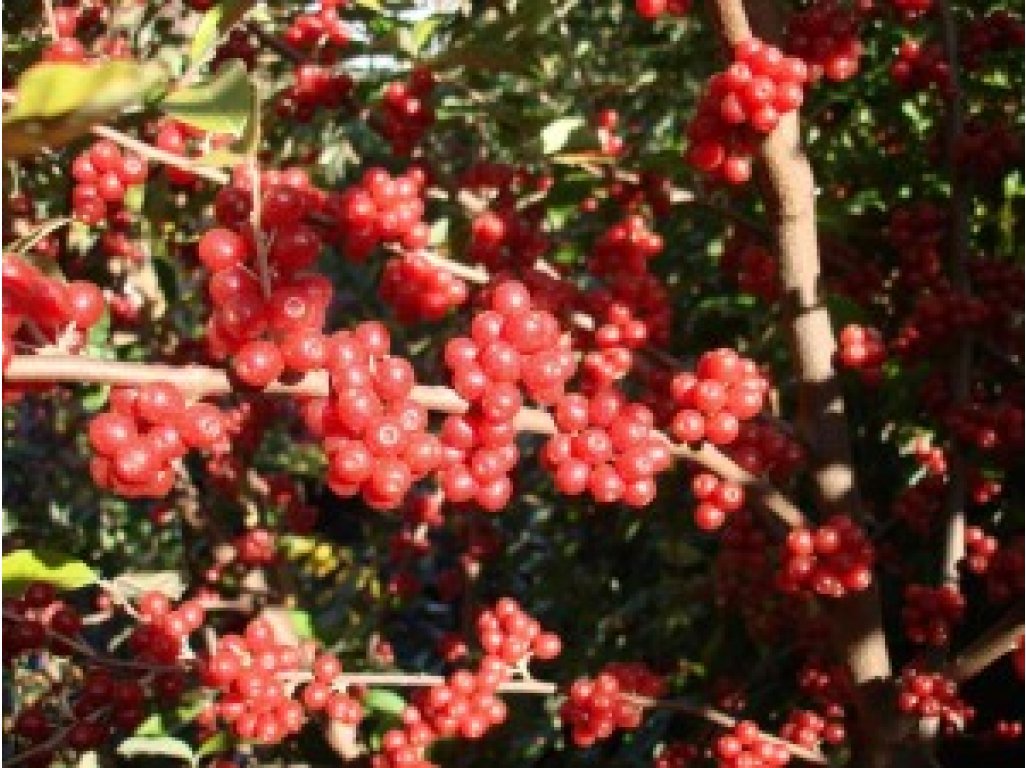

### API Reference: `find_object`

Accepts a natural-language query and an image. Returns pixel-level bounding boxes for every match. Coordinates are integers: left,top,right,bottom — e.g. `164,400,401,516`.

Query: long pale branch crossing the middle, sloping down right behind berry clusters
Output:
4,355,805,527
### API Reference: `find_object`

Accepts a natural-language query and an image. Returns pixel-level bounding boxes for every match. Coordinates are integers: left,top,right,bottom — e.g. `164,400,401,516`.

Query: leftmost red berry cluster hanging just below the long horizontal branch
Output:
88,382,229,498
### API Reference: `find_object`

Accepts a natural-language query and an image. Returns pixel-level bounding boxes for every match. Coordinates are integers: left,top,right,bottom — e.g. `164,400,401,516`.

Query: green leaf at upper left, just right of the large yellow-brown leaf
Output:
160,59,253,136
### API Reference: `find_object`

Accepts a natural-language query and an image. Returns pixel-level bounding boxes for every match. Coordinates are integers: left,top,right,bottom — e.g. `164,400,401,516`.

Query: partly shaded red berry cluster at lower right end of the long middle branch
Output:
778,515,875,598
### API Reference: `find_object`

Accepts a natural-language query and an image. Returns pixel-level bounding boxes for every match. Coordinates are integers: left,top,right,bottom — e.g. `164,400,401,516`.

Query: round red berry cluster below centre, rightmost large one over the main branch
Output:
542,389,672,508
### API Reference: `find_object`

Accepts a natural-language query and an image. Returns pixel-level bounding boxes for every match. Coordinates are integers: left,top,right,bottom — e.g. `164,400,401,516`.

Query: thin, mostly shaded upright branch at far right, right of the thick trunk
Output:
937,0,973,583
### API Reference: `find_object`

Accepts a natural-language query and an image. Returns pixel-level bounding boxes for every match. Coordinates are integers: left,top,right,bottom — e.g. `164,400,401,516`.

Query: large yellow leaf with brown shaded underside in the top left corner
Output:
3,60,167,157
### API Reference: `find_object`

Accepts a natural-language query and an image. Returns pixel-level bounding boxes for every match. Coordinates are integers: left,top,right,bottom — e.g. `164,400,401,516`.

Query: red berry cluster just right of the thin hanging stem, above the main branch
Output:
329,167,430,261
